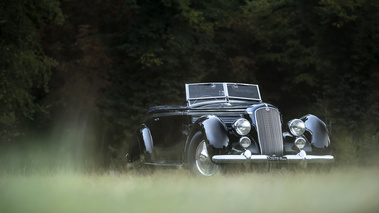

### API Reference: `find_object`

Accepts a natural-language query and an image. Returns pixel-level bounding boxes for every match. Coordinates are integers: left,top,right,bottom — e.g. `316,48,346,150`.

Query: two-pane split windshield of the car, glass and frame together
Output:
186,83,261,105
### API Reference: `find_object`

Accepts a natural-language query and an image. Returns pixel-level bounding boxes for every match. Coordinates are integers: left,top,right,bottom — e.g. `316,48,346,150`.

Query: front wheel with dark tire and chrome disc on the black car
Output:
188,132,220,176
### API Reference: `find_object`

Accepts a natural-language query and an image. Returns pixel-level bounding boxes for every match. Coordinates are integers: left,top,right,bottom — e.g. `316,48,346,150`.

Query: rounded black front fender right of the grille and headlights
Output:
300,114,330,149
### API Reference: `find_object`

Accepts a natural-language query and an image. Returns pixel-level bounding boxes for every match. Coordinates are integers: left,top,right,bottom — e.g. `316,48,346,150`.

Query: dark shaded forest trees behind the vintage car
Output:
0,0,379,172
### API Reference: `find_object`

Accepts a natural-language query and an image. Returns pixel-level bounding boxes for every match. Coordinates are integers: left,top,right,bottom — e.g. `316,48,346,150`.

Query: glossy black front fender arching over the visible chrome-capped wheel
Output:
189,115,229,149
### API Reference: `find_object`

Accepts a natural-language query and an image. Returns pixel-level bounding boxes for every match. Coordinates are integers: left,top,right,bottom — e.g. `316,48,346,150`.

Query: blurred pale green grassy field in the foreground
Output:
0,167,379,213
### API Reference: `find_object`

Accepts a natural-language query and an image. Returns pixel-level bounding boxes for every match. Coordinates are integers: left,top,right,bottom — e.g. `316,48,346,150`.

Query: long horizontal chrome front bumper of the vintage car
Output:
212,150,334,164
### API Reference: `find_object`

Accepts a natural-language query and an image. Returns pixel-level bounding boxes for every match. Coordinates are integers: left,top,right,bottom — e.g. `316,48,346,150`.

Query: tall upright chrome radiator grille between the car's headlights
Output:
255,107,283,156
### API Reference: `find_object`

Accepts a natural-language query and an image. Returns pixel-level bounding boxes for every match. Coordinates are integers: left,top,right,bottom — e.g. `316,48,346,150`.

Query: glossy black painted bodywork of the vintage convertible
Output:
128,92,331,165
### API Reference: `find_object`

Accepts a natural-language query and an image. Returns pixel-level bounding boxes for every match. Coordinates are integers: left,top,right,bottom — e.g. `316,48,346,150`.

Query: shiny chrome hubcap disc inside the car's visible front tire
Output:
196,141,219,176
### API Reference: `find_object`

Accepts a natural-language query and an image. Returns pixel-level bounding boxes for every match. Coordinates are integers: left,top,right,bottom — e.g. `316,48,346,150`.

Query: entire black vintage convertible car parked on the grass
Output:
127,83,334,176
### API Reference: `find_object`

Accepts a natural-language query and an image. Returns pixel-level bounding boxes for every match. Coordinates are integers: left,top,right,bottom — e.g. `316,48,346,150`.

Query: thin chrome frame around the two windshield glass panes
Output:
185,82,262,107
